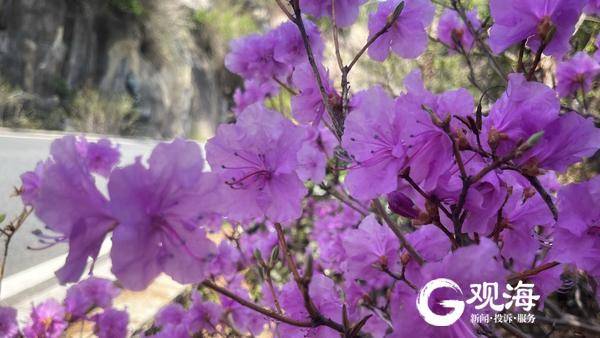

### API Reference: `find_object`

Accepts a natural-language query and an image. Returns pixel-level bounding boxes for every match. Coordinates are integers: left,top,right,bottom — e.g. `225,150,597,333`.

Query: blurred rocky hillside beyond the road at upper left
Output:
0,0,235,138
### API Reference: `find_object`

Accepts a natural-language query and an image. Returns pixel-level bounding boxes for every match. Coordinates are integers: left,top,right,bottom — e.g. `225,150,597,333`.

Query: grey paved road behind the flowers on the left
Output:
0,128,155,276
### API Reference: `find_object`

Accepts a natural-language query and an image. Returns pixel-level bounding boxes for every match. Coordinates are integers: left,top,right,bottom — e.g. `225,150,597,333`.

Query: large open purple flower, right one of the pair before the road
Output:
108,139,221,290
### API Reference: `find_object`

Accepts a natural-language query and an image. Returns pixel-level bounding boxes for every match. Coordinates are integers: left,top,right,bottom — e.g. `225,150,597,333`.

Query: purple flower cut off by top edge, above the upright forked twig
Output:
300,0,367,27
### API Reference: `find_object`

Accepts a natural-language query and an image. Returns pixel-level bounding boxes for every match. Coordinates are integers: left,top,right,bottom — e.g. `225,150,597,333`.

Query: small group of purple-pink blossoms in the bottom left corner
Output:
0,277,124,338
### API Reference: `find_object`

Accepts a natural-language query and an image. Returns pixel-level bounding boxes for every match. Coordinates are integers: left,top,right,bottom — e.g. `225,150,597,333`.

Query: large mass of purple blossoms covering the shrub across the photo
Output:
7,0,600,337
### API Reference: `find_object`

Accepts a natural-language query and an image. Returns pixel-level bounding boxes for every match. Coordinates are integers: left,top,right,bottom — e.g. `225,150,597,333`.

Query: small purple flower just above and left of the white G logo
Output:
343,215,400,285
